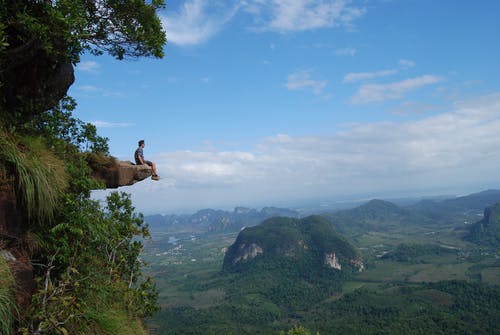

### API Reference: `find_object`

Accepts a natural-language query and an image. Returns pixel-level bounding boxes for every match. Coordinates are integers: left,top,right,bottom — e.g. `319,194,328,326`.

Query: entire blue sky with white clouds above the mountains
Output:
70,0,500,213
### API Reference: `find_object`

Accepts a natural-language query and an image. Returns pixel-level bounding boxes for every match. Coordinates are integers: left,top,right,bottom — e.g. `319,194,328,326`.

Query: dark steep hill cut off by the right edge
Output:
465,202,500,247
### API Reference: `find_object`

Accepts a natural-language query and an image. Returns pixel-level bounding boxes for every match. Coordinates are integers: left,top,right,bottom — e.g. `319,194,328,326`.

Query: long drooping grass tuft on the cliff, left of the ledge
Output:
0,133,67,221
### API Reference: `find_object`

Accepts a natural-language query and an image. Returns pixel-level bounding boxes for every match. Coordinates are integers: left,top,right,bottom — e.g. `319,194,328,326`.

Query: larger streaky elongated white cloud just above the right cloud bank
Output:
351,75,442,104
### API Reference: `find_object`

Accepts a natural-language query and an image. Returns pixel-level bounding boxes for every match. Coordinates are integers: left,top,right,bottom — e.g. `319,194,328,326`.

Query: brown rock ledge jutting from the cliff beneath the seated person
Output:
90,161,152,188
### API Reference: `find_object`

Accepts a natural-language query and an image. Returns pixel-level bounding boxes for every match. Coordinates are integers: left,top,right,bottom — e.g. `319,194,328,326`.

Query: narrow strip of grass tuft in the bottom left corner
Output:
0,255,16,335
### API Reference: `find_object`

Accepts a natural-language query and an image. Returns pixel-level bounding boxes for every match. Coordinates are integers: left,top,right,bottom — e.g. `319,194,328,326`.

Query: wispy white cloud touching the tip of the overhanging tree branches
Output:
160,0,239,46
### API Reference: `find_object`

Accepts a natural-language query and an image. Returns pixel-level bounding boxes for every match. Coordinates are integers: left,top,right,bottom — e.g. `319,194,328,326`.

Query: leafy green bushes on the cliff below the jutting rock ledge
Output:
24,192,157,334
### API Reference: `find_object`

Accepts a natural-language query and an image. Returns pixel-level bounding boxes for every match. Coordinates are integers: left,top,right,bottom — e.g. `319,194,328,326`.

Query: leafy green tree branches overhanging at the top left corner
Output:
0,0,166,65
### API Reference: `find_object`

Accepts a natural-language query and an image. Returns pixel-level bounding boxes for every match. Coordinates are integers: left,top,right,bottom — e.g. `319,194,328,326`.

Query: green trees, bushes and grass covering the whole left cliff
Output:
0,0,165,335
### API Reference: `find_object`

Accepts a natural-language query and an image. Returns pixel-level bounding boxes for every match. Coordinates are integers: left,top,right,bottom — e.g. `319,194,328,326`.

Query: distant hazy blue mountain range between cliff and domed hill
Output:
144,207,299,233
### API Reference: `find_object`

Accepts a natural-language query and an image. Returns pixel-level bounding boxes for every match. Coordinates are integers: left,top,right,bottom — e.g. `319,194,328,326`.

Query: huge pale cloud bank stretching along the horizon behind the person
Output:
120,93,500,210
